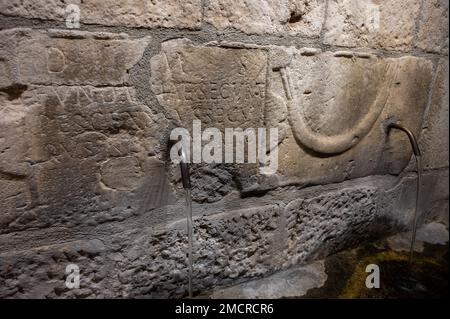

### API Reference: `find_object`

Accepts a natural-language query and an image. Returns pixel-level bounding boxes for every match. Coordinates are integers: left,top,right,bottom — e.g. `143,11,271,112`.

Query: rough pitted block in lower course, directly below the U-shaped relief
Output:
284,187,379,267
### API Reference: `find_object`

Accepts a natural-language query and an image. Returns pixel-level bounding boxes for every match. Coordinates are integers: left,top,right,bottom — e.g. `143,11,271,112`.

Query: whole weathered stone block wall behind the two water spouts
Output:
0,0,448,298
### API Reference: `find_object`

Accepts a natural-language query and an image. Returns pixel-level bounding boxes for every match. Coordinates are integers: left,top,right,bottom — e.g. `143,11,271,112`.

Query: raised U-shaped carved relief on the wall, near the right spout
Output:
280,55,397,155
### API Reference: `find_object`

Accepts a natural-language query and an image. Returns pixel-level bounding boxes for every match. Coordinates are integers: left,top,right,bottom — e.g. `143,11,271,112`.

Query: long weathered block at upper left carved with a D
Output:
0,29,149,86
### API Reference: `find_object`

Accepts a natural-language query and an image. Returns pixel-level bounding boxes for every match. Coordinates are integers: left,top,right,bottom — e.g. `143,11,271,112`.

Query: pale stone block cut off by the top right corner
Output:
416,0,448,54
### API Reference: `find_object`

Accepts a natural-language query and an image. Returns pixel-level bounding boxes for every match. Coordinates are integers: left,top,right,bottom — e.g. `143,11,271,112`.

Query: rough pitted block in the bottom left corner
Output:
0,239,111,298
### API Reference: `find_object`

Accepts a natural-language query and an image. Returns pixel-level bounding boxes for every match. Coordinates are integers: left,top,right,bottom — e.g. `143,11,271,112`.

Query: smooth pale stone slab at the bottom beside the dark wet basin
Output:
210,261,327,299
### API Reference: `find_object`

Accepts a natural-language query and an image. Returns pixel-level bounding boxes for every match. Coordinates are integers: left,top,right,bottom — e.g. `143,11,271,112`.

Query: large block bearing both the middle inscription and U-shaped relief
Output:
150,40,433,192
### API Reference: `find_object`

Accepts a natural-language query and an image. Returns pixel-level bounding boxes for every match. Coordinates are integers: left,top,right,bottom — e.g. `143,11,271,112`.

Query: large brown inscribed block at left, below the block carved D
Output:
0,86,171,232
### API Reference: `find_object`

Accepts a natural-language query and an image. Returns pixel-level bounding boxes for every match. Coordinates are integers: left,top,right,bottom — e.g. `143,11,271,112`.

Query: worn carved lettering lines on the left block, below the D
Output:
26,86,156,160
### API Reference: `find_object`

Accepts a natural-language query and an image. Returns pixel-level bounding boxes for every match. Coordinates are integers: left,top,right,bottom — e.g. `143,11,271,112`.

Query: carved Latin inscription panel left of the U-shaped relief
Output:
151,40,267,129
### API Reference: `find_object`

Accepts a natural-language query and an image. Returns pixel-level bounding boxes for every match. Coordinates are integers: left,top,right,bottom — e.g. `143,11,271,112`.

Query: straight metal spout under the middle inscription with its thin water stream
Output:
180,148,193,298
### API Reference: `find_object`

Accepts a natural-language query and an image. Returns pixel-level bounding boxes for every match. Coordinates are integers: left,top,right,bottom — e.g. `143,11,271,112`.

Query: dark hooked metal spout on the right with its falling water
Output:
385,119,422,262
